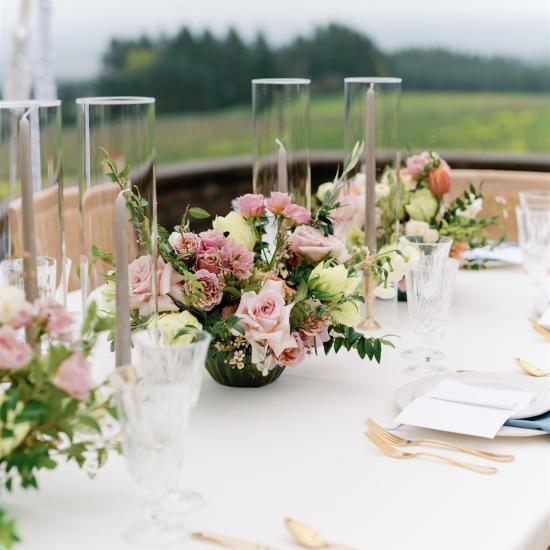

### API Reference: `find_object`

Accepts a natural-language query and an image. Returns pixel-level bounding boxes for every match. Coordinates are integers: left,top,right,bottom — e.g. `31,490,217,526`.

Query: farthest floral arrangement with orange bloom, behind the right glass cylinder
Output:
317,151,499,268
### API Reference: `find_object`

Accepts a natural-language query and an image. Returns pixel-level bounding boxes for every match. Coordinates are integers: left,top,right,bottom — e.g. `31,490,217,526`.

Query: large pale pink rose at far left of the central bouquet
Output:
128,256,183,317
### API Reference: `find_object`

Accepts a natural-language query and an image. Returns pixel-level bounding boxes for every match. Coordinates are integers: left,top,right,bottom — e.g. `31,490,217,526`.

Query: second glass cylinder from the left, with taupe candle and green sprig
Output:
76,97,157,365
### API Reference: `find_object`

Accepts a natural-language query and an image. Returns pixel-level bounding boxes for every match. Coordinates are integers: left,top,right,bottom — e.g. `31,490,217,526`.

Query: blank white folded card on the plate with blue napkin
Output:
395,380,534,438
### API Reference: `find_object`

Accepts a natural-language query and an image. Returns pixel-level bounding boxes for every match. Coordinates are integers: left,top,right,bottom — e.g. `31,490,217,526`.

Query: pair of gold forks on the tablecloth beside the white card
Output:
364,418,514,474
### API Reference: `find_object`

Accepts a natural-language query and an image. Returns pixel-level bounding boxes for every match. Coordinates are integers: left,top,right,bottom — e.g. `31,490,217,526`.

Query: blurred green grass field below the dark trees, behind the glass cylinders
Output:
64,93,550,174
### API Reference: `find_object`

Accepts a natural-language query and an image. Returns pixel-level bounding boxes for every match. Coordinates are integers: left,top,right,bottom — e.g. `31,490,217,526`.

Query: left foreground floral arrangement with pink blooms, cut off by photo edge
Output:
0,287,114,548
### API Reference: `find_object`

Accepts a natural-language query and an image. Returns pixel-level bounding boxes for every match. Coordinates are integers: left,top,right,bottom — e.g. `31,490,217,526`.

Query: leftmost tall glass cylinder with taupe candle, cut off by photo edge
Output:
0,100,69,303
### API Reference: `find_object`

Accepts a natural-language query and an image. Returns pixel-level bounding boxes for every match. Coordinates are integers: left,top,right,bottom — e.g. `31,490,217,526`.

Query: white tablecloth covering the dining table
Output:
5,268,550,550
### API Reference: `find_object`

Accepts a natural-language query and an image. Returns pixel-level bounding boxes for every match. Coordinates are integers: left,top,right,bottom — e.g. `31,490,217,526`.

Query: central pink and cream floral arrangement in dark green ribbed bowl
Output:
100,152,418,387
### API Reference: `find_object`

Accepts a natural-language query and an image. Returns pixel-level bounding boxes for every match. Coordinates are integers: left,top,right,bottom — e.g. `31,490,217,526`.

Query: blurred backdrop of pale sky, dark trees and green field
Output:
0,0,550,175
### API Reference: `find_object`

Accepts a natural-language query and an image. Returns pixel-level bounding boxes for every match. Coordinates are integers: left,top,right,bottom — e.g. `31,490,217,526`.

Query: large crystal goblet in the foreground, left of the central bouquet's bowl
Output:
112,332,210,546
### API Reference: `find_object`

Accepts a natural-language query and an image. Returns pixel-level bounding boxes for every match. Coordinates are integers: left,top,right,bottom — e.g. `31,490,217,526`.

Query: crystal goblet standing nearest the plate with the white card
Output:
404,258,459,376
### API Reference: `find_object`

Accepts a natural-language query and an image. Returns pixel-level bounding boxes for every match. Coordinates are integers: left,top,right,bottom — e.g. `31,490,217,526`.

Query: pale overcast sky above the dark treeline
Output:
0,0,550,78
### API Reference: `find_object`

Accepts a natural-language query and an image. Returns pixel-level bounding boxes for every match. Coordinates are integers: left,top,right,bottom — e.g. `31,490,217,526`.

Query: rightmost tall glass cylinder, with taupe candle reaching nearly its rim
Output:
344,77,403,330
